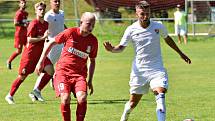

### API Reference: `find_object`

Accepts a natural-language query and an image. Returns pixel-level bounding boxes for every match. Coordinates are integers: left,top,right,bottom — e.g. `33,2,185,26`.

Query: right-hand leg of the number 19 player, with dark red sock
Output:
74,76,87,121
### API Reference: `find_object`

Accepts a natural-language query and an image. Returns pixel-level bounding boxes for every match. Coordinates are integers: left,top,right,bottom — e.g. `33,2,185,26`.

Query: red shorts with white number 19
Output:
54,73,87,97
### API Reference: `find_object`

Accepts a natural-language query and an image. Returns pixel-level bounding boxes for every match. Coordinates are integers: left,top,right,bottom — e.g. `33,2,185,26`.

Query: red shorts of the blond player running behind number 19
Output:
19,57,52,76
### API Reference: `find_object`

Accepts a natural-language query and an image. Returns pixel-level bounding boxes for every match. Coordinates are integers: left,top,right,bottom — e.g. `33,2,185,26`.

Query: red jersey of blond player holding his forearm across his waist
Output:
20,19,48,63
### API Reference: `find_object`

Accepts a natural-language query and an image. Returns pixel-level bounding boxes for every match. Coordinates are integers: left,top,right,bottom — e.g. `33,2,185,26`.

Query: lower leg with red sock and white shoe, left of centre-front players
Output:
5,75,27,104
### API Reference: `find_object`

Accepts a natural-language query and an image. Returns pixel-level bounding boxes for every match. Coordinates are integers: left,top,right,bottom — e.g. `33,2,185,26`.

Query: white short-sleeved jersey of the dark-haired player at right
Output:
120,21,168,76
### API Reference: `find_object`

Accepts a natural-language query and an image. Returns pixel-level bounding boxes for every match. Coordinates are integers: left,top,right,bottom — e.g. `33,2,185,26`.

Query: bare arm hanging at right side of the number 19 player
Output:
88,58,96,95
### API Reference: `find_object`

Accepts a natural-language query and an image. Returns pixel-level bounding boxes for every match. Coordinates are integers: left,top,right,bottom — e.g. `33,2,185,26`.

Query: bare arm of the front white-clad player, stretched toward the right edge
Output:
164,36,191,64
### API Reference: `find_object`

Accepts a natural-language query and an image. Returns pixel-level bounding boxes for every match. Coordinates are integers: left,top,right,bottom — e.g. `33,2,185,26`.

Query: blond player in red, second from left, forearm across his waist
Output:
5,2,48,104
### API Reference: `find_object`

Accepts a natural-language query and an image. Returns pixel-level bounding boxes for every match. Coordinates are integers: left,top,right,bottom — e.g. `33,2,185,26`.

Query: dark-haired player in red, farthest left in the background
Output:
7,0,28,69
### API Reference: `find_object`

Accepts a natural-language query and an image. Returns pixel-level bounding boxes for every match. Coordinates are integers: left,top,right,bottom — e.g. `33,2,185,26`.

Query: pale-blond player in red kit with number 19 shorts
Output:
36,12,98,121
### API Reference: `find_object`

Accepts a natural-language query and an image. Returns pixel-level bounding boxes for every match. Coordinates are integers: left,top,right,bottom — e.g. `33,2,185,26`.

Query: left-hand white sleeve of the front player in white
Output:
120,27,131,46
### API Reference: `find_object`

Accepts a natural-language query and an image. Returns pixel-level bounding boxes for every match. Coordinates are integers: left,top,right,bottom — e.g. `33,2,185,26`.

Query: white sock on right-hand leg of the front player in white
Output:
155,93,166,121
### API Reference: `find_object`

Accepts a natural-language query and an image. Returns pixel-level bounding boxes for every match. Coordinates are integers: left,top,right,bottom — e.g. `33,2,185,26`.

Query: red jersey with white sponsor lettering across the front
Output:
55,28,98,77
